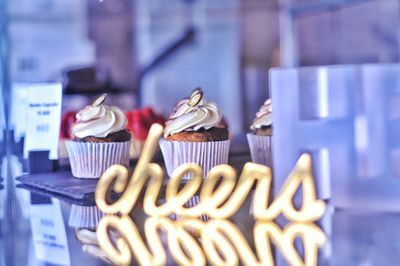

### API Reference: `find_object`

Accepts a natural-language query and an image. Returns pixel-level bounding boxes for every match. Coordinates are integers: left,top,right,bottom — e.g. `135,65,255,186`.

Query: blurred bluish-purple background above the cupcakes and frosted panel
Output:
1,0,400,134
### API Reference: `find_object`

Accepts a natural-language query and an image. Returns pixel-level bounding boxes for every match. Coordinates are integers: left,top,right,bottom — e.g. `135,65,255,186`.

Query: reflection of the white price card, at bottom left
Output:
30,199,71,265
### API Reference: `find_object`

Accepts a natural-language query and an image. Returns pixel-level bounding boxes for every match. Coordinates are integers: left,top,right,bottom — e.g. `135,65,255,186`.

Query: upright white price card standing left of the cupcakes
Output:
24,83,62,160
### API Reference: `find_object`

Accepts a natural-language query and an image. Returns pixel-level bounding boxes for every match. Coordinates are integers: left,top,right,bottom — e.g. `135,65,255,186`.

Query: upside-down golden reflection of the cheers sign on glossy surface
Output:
97,216,326,265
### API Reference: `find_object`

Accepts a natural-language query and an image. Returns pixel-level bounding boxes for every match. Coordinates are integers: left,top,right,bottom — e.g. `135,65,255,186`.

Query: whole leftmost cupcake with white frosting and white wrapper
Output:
66,94,131,178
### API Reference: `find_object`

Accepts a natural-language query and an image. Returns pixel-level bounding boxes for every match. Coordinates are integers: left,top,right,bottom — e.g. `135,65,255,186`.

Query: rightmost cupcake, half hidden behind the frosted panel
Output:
247,99,272,167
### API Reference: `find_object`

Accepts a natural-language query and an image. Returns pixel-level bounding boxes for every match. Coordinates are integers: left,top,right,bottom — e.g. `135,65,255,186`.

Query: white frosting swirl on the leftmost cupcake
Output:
72,104,127,138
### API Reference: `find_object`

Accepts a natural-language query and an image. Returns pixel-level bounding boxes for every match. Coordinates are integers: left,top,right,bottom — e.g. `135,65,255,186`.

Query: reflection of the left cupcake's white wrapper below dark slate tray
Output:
68,204,104,228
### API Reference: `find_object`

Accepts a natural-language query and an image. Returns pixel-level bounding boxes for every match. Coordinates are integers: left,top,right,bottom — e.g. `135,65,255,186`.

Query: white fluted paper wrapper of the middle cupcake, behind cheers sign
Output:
160,139,230,180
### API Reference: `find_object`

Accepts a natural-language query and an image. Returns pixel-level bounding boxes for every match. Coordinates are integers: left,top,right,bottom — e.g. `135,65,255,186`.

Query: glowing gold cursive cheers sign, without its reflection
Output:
96,124,325,222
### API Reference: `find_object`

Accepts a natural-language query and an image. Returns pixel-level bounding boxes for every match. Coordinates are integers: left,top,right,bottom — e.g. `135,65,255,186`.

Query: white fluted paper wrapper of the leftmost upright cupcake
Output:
65,141,130,178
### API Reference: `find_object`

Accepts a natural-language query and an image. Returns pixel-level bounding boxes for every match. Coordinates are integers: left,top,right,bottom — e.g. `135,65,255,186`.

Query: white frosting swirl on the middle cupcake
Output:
164,98,222,137
